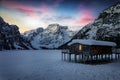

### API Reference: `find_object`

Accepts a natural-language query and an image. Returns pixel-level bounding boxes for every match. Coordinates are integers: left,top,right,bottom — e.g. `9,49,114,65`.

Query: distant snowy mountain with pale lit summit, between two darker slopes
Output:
23,24,76,49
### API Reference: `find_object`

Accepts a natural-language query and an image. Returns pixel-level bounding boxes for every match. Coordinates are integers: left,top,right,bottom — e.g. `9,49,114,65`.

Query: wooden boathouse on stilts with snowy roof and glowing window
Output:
62,39,119,62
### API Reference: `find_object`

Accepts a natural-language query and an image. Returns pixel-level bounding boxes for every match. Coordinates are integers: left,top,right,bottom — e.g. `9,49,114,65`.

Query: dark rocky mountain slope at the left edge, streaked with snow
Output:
0,17,32,50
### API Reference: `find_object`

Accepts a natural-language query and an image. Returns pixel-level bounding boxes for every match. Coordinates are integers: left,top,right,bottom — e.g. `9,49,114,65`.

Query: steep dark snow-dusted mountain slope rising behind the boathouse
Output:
73,3,120,46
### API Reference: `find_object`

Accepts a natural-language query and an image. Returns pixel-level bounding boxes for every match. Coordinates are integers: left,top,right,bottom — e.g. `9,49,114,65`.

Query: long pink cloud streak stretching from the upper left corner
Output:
2,1,51,18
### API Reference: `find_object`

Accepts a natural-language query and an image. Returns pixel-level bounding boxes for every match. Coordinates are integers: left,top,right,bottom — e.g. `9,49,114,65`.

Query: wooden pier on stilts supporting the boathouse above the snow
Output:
61,50,120,63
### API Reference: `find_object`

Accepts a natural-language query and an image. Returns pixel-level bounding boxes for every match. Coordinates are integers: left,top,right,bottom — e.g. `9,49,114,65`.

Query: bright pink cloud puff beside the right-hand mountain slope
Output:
75,10,95,26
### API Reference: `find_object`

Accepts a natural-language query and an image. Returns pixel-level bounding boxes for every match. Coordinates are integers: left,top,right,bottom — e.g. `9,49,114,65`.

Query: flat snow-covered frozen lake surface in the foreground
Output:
0,50,120,80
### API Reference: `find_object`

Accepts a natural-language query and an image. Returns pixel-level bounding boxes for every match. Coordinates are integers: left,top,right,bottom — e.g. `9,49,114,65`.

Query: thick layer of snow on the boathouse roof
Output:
68,39,116,46
